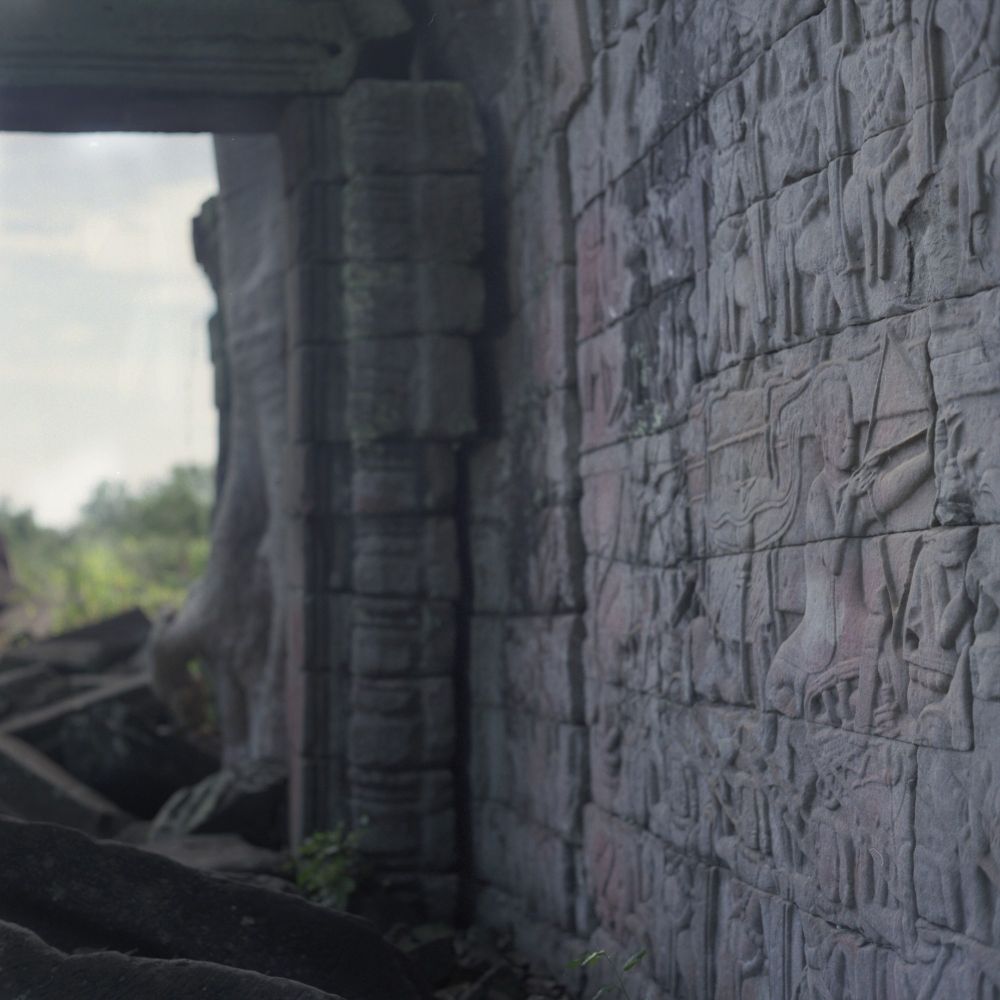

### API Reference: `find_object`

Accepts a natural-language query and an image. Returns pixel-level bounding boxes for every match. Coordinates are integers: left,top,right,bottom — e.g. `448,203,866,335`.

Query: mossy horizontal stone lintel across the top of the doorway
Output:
0,0,409,131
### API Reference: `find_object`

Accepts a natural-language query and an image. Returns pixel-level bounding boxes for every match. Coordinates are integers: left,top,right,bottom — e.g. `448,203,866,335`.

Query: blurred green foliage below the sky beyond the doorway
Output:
0,466,213,631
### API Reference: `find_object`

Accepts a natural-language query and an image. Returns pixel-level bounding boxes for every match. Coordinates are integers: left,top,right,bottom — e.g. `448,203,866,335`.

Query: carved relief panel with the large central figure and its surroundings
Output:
664,317,992,749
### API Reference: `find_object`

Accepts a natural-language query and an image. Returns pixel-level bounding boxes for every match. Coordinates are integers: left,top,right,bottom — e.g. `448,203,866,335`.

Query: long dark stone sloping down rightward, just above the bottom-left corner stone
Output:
0,819,420,1000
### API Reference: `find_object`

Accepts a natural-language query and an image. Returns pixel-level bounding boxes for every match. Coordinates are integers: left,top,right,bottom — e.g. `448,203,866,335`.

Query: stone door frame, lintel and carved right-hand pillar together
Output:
0,0,485,915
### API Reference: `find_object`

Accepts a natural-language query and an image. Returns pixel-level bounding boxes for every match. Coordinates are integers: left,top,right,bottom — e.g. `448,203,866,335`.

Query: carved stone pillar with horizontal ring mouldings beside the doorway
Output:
284,80,483,914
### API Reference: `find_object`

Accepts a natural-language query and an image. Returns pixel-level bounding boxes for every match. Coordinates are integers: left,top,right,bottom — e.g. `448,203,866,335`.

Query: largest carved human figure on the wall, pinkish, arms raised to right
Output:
765,364,931,725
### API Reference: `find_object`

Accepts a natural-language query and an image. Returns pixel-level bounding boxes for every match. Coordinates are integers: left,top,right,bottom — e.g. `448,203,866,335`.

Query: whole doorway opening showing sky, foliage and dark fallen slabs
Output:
0,132,225,833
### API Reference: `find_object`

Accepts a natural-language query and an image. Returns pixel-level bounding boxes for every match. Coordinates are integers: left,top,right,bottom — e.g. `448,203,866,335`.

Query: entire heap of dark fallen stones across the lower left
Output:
0,611,569,1000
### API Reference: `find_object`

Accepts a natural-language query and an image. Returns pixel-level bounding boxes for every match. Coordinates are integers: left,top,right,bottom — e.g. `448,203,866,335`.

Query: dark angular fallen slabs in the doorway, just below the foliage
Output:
0,610,218,836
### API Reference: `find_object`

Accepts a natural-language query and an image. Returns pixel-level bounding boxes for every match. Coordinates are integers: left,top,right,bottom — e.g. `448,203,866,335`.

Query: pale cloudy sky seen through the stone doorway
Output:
0,133,218,527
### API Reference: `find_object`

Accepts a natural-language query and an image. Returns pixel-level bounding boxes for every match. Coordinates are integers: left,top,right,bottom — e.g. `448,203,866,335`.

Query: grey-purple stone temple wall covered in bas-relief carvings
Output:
431,0,1000,1000
